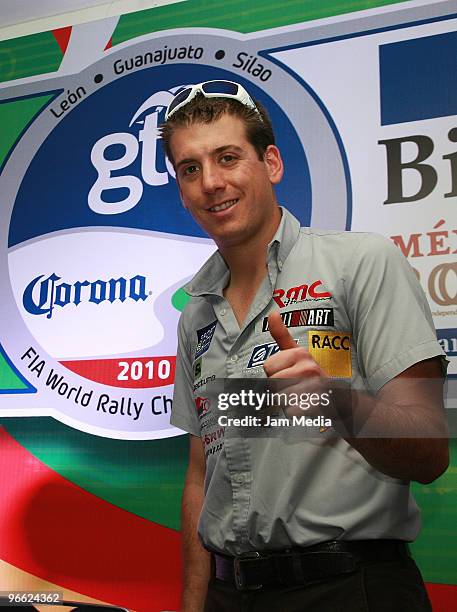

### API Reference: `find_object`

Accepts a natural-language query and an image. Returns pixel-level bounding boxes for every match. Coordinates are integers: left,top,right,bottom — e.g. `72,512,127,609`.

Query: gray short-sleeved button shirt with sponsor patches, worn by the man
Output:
171,209,443,555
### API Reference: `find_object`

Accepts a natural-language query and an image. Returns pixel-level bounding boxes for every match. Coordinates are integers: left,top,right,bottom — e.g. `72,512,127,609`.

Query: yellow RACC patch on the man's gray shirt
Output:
308,330,352,378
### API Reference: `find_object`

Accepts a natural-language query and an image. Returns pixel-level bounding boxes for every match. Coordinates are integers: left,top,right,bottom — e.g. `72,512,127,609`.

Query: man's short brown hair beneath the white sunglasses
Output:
160,94,275,166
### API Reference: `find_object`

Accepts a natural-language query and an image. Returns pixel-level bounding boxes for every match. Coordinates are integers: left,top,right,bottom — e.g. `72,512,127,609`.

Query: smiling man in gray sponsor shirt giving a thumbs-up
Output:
162,81,448,612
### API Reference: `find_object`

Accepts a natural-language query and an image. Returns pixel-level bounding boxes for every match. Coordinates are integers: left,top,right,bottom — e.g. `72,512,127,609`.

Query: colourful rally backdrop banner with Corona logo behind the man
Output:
0,0,457,612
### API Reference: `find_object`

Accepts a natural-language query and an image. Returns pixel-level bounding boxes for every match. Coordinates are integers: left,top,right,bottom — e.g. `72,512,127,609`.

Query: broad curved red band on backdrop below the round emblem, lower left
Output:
0,428,181,612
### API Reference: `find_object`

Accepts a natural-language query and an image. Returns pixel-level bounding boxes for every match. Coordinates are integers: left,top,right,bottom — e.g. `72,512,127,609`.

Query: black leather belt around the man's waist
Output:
213,540,409,590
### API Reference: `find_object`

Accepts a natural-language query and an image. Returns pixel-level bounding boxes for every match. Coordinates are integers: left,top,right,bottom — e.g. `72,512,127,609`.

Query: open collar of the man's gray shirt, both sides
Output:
184,206,300,297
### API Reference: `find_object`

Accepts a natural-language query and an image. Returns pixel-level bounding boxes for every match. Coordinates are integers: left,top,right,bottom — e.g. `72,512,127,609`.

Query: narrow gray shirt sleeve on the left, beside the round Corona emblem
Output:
170,313,200,436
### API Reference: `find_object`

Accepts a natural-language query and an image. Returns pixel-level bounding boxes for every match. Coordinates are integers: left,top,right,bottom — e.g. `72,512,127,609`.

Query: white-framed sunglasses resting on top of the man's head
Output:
165,81,260,121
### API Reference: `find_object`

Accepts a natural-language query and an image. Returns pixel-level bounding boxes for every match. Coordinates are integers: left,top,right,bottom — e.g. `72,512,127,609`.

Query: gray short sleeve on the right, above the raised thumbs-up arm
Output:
343,234,444,393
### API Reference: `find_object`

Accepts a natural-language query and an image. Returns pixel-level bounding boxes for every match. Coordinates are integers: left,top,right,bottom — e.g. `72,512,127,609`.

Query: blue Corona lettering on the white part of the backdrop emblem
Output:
22,273,148,319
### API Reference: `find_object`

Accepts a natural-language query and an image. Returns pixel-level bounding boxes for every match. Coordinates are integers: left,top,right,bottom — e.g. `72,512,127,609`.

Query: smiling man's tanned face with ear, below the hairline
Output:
167,114,283,247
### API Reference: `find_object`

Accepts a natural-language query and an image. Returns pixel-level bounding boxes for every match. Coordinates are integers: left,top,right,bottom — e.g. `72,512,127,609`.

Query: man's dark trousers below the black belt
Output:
204,557,432,612
